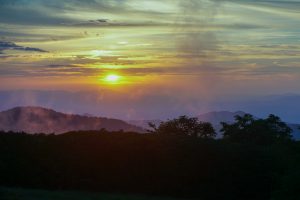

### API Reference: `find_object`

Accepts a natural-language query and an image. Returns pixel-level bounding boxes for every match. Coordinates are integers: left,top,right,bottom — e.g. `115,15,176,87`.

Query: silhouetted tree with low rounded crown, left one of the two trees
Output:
149,116,216,138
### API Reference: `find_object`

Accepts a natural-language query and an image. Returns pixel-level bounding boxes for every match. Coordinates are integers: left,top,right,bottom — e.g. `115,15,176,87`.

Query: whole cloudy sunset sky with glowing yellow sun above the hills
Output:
0,0,300,119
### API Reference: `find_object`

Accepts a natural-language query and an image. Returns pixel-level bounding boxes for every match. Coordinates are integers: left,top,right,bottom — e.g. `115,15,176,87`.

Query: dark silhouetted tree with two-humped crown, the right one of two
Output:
221,114,292,144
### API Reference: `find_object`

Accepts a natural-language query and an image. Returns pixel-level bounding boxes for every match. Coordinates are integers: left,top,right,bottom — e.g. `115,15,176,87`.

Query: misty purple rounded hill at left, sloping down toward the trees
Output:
0,107,144,134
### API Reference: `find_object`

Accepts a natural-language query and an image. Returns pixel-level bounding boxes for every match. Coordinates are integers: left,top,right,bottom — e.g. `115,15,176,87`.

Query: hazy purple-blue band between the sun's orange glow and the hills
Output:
0,89,300,124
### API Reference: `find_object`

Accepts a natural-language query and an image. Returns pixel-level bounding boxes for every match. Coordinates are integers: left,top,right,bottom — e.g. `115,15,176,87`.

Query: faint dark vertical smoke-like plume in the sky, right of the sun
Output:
175,0,219,68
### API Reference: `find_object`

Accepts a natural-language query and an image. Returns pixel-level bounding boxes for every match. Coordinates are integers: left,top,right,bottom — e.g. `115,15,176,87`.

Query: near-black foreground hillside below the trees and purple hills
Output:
0,131,300,200
